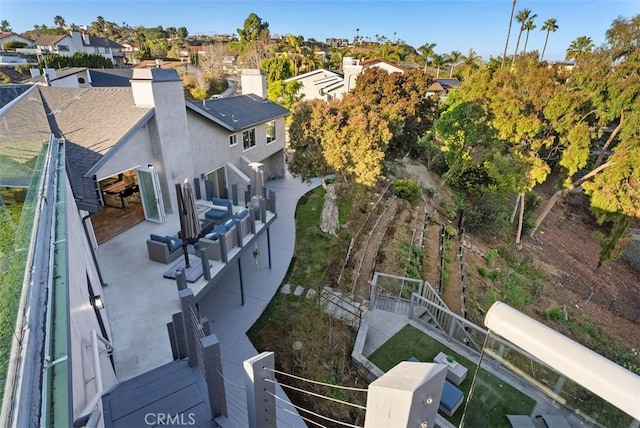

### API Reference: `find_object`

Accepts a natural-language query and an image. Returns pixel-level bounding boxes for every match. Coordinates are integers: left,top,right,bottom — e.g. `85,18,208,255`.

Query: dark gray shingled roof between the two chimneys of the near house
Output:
187,95,289,131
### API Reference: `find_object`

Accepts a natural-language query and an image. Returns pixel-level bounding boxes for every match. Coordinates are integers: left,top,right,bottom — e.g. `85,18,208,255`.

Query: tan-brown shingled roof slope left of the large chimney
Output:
40,87,153,211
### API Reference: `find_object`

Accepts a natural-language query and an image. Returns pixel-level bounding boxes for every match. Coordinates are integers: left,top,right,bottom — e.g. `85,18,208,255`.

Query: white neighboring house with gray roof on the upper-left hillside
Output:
35,30,125,65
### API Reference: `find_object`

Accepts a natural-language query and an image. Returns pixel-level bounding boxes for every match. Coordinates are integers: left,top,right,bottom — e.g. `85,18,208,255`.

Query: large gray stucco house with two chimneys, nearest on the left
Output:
0,68,288,426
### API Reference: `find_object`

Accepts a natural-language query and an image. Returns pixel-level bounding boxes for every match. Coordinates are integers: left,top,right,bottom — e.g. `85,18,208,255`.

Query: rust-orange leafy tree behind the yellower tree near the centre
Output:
351,68,437,158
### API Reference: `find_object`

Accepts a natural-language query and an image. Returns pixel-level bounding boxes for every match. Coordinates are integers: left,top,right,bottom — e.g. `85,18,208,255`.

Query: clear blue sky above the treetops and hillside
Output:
0,0,640,60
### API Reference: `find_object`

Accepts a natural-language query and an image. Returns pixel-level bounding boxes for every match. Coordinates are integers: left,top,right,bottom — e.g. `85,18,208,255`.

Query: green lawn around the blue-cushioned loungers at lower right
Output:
369,325,535,427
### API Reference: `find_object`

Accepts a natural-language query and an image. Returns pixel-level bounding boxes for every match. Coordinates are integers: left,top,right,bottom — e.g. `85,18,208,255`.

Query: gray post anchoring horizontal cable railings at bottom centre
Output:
242,352,276,428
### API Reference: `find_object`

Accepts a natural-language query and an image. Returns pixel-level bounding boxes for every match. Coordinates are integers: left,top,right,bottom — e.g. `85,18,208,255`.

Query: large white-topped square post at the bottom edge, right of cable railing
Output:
364,361,447,428
